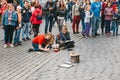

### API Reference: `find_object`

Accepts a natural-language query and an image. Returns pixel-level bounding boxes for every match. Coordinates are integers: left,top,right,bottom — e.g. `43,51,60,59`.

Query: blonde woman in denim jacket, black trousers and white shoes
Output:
2,4,17,48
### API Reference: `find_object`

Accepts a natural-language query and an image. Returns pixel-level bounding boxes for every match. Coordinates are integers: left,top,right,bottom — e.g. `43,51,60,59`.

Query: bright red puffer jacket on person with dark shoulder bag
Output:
30,8,42,24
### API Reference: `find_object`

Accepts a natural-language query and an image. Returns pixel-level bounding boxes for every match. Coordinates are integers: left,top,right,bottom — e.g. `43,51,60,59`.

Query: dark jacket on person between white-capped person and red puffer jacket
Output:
22,7,32,22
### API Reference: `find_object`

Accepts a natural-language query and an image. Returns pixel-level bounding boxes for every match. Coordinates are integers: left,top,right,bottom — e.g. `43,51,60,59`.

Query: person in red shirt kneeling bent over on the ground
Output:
28,33,54,52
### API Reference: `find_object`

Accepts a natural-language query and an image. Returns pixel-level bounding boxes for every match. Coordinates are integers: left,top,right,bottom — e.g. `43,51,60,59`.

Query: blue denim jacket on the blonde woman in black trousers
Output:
2,10,18,27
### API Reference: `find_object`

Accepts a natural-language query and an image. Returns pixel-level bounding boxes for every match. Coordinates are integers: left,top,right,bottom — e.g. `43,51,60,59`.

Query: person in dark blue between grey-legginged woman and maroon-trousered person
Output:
65,0,72,23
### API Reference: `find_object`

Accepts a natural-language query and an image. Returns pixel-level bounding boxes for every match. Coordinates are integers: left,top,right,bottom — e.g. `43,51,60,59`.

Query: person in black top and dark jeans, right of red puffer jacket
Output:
45,0,55,33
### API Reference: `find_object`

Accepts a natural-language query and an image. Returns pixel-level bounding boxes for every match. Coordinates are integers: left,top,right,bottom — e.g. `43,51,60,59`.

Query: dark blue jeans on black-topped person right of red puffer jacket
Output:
45,15,53,34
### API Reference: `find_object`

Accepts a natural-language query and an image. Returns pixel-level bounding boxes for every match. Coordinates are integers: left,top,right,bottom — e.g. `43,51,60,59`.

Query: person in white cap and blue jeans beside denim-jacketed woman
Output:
14,6,22,46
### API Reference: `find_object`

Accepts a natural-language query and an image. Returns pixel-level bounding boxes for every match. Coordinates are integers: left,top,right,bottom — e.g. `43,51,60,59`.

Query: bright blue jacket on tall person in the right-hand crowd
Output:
91,2,102,17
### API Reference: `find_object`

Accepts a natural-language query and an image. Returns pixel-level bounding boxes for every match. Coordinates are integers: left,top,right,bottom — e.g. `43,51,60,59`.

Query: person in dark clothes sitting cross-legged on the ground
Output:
56,25,74,49
